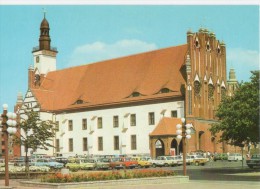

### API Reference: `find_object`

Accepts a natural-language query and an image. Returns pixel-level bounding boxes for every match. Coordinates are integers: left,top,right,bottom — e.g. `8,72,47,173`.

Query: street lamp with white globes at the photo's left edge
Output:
0,104,16,186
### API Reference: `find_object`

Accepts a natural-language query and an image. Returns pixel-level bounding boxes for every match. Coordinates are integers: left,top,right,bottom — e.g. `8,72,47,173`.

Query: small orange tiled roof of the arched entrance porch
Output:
150,117,182,136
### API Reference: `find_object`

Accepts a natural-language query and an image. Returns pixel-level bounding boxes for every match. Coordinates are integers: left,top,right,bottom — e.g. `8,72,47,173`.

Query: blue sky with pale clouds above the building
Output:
0,5,259,110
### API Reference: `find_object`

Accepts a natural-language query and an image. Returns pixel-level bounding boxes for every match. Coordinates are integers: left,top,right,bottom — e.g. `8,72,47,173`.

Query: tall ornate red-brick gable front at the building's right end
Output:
185,28,228,152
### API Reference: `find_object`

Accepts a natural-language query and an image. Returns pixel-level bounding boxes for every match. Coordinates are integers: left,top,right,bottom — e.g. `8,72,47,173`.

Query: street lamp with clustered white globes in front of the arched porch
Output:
176,118,192,176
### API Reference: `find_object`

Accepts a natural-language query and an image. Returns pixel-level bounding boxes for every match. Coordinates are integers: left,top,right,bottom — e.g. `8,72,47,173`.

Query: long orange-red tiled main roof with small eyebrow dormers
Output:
31,44,187,111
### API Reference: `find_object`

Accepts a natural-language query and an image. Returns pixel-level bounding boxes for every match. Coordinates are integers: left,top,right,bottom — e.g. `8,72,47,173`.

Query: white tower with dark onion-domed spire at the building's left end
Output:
29,13,58,88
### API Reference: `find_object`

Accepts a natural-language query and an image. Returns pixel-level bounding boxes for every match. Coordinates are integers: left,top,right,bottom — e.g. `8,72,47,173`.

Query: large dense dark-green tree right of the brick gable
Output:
210,71,260,146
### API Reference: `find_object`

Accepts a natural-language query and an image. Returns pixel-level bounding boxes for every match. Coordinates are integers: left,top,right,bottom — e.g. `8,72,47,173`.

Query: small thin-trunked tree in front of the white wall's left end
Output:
13,109,56,176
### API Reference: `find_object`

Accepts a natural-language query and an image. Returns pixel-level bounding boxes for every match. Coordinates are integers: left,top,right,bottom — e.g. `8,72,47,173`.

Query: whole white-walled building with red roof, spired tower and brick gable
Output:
14,17,237,157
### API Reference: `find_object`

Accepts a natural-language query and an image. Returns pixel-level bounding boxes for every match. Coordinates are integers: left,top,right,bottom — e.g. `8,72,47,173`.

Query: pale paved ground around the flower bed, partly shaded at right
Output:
0,161,260,189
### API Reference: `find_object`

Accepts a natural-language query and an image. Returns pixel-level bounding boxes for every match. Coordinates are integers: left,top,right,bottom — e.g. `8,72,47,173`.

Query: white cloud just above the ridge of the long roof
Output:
69,39,157,66
